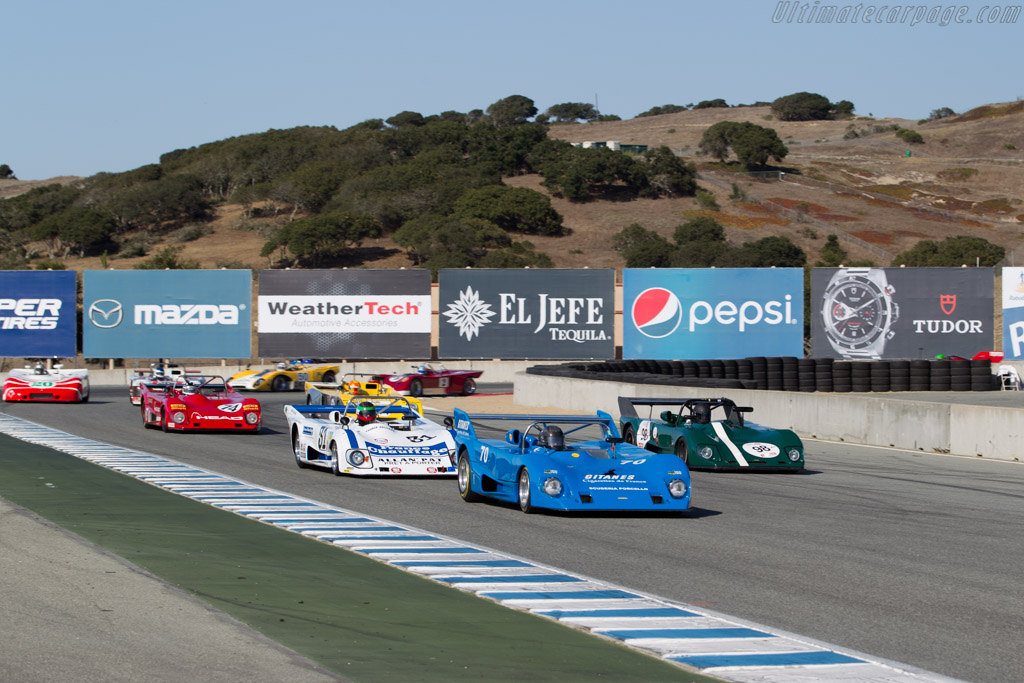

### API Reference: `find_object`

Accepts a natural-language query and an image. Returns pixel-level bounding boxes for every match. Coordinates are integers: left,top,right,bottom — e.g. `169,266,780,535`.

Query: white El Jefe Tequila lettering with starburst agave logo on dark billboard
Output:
443,287,608,343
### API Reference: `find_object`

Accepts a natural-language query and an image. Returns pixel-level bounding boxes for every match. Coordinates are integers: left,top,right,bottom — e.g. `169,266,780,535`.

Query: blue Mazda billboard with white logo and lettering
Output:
82,270,252,358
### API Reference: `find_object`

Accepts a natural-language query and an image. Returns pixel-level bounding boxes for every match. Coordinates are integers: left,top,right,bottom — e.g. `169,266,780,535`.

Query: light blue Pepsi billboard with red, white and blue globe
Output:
623,268,804,360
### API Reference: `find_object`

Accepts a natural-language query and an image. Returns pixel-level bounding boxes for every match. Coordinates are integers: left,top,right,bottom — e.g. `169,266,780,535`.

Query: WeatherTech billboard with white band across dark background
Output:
257,270,431,360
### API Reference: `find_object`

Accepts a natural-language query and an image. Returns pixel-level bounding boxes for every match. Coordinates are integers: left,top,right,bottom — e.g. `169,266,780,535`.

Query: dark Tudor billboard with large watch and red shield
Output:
811,268,995,359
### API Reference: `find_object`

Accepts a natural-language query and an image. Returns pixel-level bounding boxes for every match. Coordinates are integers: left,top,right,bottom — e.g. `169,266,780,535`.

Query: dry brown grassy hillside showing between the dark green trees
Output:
8,102,1024,268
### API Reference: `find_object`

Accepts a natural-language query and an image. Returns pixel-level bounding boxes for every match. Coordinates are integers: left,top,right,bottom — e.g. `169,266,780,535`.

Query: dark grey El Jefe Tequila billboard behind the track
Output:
437,268,615,359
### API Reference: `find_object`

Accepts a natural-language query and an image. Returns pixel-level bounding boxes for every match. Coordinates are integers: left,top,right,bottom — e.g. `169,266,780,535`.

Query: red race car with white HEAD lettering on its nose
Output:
141,375,261,434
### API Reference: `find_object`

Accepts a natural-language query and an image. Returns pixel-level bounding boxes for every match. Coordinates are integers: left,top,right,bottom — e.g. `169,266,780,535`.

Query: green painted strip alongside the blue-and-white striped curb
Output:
0,434,717,682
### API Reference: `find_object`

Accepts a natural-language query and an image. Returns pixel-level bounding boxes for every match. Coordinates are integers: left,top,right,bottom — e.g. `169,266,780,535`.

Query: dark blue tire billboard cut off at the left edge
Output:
0,270,78,358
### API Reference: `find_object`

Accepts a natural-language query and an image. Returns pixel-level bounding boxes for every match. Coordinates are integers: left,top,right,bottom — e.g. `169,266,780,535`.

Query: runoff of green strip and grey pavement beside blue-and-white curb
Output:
0,435,716,683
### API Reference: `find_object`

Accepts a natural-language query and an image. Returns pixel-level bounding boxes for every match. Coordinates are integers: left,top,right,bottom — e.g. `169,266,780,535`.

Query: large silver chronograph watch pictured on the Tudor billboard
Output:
821,268,899,359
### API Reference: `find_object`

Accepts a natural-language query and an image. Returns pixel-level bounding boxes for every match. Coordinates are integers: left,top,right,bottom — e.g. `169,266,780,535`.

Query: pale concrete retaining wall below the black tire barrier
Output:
514,372,1024,460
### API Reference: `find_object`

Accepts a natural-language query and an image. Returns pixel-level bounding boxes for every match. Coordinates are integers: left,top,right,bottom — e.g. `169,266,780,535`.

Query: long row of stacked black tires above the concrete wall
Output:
526,356,999,393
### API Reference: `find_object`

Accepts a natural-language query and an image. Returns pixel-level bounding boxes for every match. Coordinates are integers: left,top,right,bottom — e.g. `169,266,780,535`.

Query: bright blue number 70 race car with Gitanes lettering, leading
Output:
452,409,690,513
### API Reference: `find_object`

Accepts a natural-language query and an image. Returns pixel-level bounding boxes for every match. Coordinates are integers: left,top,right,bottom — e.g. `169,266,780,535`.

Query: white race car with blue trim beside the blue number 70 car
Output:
285,396,456,476
